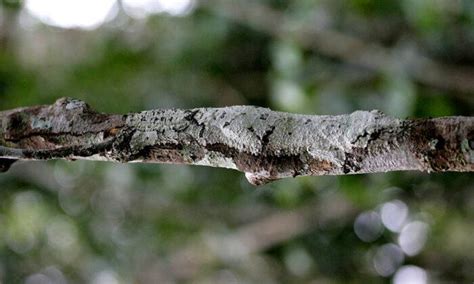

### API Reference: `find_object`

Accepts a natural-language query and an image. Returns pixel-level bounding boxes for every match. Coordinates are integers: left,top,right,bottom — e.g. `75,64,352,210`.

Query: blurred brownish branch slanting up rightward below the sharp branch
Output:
166,194,358,281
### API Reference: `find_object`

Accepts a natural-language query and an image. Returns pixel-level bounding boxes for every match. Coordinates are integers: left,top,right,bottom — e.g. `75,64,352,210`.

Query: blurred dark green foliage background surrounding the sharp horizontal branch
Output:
0,0,474,284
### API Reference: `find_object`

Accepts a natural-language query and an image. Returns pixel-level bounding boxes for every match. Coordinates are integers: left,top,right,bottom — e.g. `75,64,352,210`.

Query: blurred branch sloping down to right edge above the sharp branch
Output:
202,0,474,98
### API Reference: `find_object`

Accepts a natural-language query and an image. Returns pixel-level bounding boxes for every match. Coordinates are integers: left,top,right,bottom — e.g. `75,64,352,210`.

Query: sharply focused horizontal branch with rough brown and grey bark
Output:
0,98,474,185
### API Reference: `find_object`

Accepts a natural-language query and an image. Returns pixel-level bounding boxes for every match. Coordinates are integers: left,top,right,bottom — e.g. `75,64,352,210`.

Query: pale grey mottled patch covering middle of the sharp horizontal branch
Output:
126,106,408,183
